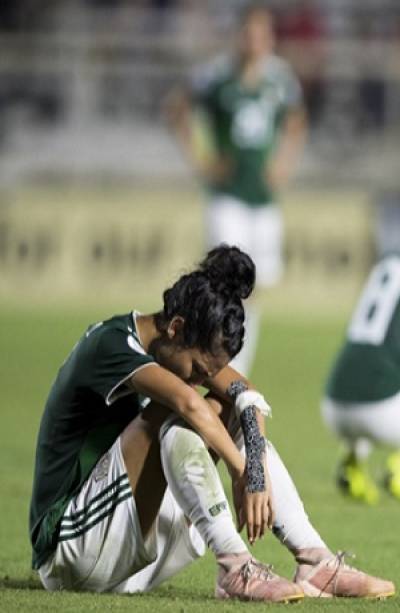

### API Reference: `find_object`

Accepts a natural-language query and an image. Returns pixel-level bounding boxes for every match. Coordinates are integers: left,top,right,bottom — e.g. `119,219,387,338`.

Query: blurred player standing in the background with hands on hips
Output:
169,4,305,373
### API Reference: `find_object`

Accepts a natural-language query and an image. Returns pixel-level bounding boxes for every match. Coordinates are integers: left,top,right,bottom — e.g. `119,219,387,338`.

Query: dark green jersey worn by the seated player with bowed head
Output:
30,312,154,568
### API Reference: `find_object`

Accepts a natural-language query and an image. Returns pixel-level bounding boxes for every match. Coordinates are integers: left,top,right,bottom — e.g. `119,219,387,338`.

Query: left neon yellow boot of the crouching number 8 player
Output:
336,453,379,505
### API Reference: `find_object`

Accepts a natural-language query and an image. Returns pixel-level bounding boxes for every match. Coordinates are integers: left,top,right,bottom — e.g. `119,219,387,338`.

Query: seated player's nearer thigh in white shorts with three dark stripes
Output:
39,406,173,591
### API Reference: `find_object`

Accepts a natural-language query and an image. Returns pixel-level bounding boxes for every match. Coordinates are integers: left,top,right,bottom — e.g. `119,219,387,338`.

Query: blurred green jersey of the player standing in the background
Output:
192,56,302,206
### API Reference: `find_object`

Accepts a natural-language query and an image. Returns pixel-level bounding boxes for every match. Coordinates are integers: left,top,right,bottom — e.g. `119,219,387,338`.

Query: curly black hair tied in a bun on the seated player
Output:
158,244,256,358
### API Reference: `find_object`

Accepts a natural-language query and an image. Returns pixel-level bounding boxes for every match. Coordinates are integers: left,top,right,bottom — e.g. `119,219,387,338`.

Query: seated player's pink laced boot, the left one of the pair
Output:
215,553,304,602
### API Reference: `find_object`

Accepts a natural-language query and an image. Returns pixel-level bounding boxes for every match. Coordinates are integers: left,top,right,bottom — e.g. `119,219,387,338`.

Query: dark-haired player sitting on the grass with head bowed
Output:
30,245,394,601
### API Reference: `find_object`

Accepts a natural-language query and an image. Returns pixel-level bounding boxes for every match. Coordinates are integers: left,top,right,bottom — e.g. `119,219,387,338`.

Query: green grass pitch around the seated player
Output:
0,308,400,613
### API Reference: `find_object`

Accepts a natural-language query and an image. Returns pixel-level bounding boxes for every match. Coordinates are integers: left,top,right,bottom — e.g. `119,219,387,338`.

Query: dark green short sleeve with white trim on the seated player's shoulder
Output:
91,328,156,406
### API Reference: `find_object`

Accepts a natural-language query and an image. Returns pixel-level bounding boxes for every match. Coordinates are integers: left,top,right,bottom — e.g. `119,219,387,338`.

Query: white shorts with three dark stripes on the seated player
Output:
39,438,205,592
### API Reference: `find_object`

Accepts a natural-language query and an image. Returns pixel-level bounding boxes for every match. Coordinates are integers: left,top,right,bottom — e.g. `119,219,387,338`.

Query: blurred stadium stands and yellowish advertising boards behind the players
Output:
0,0,400,310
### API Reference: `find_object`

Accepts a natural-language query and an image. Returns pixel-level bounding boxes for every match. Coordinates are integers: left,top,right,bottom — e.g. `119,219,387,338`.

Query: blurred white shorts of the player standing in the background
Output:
206,196,283,287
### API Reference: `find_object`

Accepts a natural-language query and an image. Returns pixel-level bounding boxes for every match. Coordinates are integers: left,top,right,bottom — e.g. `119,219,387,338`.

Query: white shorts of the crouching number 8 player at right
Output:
321,393,400,447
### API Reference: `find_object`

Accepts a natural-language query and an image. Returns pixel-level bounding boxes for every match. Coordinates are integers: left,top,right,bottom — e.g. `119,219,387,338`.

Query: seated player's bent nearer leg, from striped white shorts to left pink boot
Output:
40,405,302,601
